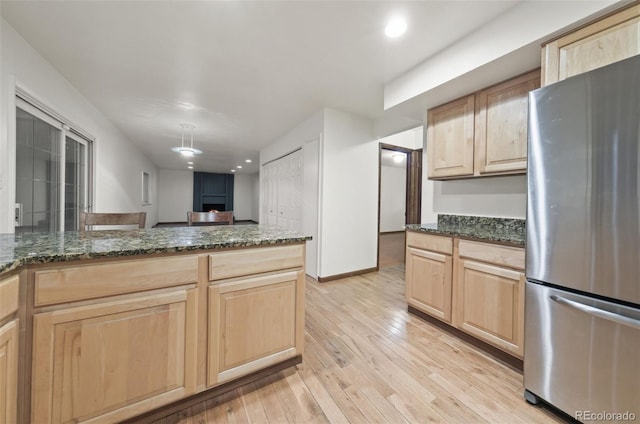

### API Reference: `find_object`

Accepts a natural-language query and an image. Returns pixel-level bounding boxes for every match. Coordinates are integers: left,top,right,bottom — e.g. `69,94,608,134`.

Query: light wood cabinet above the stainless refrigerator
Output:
542,2,640,85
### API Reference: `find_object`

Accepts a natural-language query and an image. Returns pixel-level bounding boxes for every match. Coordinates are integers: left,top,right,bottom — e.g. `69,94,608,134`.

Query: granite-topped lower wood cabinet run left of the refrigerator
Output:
406,215,525,368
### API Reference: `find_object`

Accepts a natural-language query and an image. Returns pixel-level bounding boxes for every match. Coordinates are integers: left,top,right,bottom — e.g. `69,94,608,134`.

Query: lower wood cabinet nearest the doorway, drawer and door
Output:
406,232,453,323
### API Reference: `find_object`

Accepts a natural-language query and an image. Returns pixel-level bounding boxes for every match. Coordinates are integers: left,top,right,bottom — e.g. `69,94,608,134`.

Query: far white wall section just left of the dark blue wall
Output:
158,169,193,222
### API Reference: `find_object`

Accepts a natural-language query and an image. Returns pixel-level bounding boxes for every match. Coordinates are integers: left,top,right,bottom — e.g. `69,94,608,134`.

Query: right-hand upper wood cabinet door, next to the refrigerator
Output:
475,70,540,174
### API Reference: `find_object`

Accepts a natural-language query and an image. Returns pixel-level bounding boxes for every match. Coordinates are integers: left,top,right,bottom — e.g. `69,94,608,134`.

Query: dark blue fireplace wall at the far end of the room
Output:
193,172,238,212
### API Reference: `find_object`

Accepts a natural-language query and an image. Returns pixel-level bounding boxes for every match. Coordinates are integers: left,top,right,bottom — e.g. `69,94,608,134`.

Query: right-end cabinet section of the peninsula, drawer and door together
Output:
207,245,305,386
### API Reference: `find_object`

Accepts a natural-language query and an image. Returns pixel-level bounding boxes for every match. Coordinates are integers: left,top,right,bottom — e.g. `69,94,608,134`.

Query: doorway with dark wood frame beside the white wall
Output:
377,143,422,269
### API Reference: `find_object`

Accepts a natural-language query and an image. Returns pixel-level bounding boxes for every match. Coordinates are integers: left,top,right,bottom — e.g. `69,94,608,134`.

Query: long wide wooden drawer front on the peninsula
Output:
35,255,198,306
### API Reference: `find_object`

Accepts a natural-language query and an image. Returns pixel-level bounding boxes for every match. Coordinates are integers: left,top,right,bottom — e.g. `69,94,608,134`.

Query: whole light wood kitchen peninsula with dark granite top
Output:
0,225,310,423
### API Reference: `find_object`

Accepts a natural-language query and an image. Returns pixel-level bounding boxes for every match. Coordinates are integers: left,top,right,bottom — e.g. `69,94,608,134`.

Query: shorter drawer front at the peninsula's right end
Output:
209,244,304,281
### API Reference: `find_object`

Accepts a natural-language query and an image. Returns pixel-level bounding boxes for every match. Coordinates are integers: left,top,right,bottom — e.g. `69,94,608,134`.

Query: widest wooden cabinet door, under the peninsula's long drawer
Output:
31,289,197,423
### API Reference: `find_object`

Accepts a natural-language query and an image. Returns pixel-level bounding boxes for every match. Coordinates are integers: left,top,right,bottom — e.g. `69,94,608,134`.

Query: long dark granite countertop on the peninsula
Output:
0,225,311,274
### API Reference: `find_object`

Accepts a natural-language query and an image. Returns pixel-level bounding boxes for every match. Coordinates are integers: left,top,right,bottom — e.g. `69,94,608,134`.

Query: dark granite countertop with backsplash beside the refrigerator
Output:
406,215,525,247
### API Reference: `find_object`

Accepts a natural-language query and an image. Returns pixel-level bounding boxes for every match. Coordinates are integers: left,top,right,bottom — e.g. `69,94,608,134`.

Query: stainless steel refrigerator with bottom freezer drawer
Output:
524,56,640,422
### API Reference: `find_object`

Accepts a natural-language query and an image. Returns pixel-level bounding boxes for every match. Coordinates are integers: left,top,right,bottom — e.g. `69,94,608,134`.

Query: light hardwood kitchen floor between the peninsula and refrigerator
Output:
149,265,564,424
